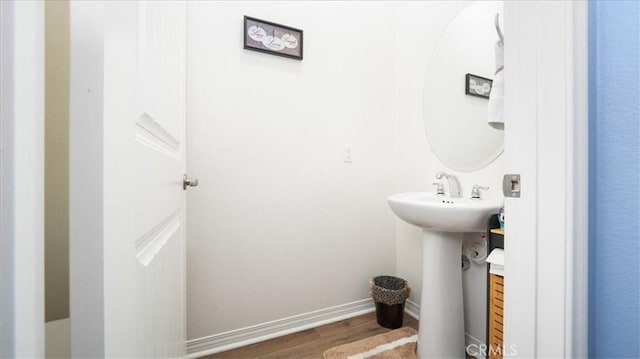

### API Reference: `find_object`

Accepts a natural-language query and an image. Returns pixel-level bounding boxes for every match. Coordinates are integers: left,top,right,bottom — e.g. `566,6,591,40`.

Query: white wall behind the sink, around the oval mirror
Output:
394,1,503,341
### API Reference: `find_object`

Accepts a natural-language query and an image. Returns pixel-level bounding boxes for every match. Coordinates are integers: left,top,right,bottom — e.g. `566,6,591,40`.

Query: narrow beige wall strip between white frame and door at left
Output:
45,1,69,322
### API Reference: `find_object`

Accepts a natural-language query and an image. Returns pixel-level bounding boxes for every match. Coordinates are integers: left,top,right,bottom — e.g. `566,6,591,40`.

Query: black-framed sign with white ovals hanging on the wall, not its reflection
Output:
243,15,303,60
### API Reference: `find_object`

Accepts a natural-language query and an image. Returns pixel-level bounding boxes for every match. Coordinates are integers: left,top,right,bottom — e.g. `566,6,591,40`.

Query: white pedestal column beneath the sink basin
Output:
418,230,465,359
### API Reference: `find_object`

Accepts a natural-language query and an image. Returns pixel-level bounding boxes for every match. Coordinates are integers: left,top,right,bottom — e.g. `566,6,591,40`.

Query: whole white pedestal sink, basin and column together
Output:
387,192,502,359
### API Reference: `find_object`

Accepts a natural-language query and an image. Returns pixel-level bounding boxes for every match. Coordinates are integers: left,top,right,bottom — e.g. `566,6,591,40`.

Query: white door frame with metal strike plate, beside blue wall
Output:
504,1,588,358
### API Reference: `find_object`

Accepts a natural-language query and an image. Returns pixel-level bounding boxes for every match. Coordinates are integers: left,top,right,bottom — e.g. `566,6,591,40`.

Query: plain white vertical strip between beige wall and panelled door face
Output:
69,1,107,358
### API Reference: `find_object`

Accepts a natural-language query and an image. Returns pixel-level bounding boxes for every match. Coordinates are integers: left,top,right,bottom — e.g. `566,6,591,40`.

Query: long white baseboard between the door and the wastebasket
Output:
187,299,375,358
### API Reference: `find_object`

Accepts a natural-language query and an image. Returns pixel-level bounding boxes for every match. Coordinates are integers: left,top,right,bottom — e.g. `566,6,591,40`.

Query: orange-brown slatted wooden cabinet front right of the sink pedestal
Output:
488,274,504,359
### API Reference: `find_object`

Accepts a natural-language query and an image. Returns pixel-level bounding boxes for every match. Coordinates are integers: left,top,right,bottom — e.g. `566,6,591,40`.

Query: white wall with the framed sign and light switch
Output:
187,2,396,339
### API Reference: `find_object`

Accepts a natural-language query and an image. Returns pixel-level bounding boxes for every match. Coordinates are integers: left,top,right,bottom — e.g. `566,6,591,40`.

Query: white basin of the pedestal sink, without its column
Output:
387,192,502,232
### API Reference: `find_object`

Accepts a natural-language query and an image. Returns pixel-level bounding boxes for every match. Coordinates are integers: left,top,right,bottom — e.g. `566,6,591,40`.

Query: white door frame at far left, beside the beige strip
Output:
0,1,45,358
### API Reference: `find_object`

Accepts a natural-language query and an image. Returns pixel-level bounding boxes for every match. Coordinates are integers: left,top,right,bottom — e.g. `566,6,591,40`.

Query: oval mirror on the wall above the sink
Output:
423,1,504,172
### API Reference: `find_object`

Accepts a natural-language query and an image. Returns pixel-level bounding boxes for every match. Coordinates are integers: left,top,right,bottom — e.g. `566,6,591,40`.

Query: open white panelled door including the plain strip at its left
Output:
70,1,186,358
